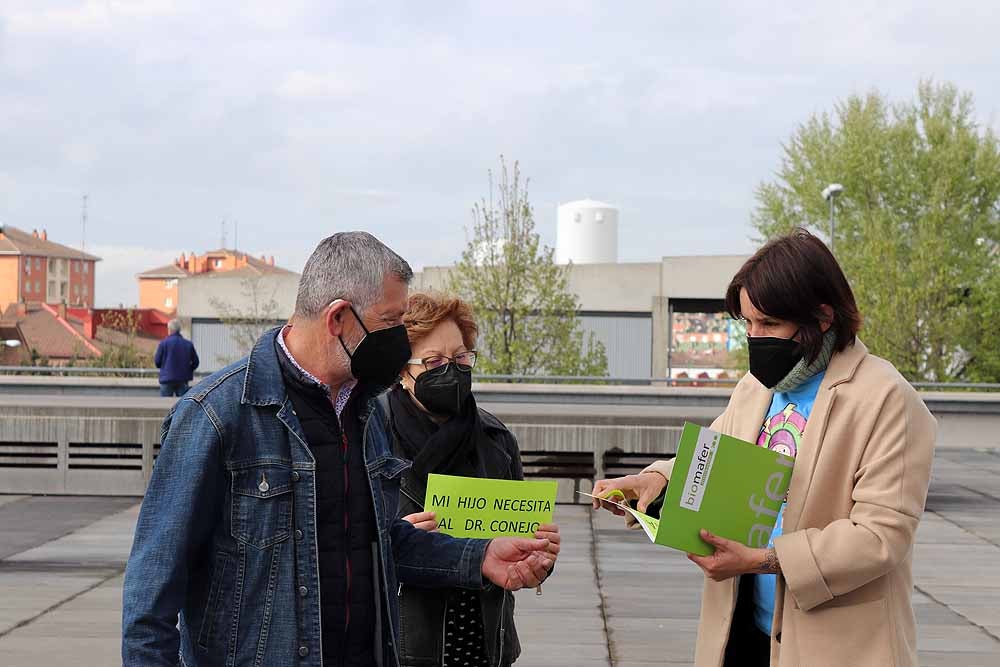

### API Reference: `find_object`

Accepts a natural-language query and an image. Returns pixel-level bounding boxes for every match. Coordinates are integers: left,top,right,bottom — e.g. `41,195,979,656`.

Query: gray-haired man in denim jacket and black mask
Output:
122,232,555,667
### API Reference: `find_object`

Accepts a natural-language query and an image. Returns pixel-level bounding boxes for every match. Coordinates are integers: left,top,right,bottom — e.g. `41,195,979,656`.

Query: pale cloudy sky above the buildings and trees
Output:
0,0,1000,304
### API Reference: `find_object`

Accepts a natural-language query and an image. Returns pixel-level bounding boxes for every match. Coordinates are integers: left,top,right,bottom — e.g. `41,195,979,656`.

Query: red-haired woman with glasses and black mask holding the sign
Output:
380,294,560,667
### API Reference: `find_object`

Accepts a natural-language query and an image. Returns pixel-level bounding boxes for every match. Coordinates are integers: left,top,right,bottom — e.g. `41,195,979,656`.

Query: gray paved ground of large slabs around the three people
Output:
0,450,1000,667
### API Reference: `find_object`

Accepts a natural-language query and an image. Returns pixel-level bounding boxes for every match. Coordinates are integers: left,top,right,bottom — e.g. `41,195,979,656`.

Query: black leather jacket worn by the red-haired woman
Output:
379,395,524,667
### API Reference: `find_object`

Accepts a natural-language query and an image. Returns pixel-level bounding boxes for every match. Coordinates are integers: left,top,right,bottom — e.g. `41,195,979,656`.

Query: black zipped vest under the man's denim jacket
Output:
279,366,381,667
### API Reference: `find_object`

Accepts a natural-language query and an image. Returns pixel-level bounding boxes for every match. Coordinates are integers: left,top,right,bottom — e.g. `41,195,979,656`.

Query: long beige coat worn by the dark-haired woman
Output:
647,341,937,667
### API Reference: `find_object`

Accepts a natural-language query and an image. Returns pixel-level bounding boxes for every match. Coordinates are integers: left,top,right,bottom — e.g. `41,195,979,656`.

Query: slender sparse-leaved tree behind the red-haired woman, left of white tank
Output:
448,156,608,376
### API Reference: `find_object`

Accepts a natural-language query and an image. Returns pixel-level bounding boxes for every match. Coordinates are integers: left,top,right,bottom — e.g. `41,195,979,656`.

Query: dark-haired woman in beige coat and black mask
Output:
595,230,936,667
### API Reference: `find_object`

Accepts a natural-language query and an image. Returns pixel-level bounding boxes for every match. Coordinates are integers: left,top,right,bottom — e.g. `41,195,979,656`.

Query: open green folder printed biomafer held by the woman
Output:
588,423,795,556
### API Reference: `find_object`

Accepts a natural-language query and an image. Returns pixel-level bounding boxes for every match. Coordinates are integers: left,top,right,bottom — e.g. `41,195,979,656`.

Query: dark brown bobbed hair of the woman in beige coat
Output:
726,227,861,362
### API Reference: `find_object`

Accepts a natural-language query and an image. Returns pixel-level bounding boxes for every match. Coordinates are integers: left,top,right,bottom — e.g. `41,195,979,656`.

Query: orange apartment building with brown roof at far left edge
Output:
0,225,100,312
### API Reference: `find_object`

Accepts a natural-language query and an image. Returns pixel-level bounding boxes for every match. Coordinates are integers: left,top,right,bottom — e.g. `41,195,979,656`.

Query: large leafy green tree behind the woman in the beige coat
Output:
753,82,1000,382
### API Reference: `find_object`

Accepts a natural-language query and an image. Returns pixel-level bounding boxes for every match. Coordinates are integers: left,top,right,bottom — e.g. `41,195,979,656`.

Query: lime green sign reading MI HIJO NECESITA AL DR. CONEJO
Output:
424,474,557,539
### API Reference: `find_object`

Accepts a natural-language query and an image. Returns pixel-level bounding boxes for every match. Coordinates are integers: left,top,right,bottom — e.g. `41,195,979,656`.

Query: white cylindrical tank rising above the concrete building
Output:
556,199,618,264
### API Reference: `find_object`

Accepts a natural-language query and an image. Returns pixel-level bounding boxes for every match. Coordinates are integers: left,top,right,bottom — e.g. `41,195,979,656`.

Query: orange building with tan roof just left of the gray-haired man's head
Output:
136,249,288,314
